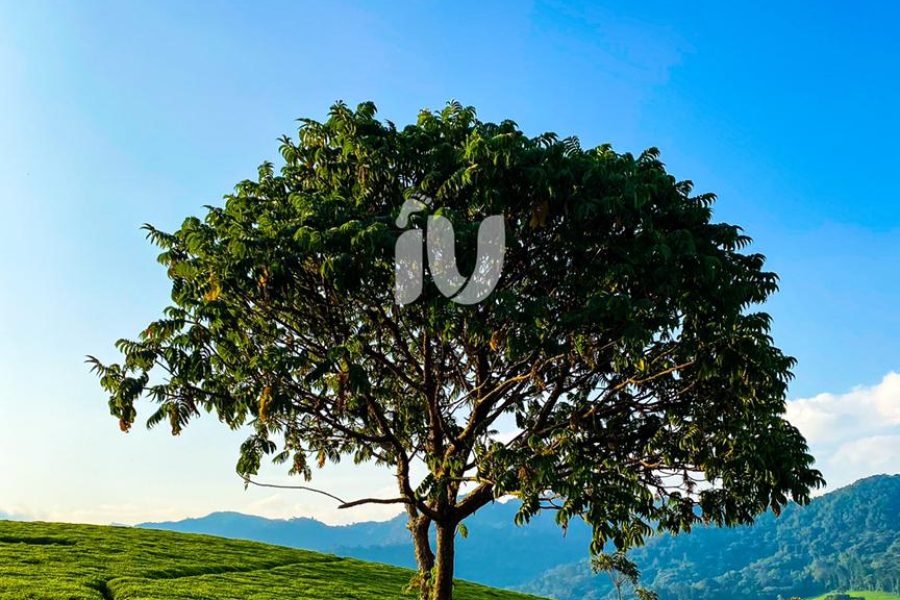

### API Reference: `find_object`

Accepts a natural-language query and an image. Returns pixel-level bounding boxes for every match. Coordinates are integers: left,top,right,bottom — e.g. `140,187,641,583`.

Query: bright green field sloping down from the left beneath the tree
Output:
0,521,534,600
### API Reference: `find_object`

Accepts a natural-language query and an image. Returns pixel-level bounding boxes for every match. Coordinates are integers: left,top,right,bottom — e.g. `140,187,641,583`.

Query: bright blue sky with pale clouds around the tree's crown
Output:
0,0,900,523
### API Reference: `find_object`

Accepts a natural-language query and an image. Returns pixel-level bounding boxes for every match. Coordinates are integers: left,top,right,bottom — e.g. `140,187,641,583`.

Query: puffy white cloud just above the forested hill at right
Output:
787,371,900,489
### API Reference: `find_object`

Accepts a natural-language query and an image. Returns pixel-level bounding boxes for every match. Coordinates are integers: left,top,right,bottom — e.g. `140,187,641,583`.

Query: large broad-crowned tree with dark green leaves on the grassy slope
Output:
89,103,822,600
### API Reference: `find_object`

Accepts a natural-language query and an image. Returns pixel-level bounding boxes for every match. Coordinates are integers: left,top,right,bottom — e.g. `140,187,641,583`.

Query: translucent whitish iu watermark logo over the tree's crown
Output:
394,196,506,305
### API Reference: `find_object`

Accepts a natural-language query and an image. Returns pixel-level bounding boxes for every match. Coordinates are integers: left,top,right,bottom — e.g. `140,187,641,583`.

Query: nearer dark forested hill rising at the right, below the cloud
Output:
522,475,900,600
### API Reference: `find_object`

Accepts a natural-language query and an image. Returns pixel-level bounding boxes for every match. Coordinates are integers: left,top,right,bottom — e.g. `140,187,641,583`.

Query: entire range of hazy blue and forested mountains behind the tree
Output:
139,475,900,600
